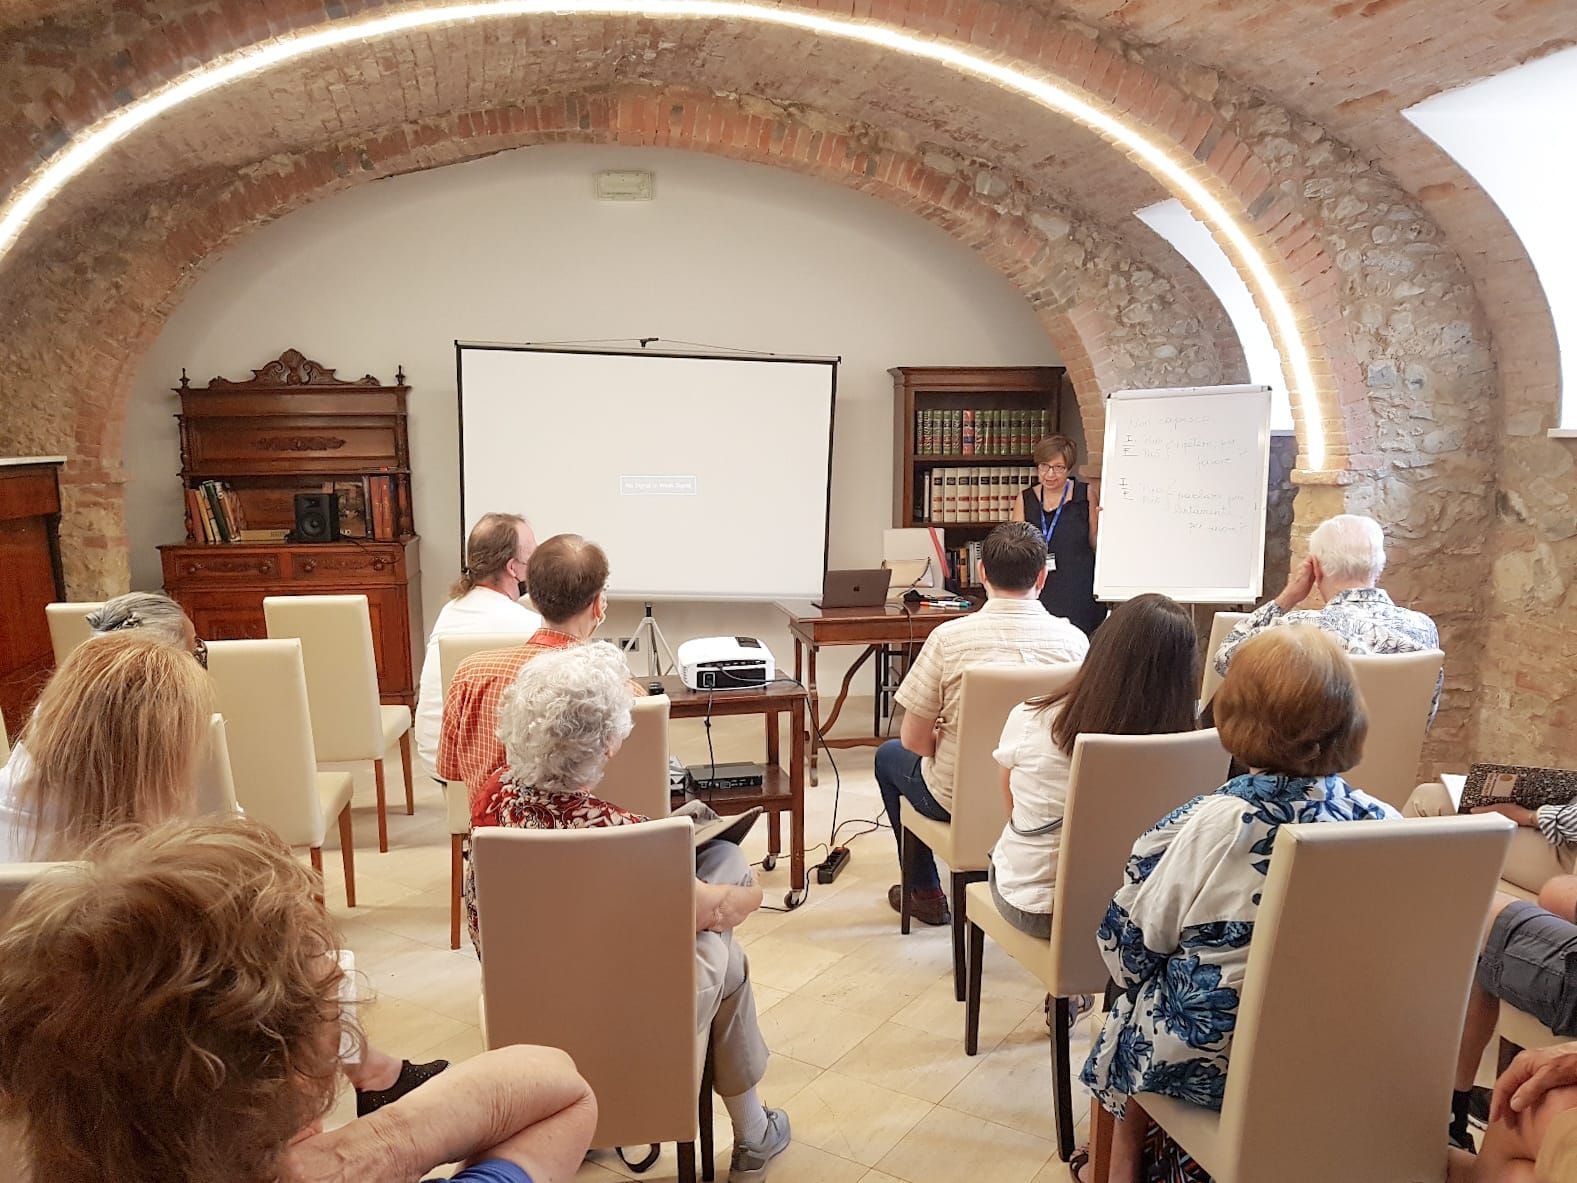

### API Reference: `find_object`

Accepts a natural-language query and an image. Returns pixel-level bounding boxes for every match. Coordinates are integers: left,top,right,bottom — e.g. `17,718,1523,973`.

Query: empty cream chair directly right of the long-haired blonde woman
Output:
208,637,356,907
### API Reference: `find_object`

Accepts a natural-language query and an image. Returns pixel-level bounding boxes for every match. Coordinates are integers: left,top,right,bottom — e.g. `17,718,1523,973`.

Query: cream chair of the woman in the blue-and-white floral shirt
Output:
1137,815,1512,1183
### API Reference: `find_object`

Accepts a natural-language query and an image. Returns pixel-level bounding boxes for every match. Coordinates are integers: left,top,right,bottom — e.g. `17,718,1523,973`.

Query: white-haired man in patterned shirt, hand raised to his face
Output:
1216,514,1445,719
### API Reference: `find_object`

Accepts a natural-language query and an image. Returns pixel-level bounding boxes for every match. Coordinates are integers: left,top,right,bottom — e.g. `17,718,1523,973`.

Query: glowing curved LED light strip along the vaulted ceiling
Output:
0,0,1325,468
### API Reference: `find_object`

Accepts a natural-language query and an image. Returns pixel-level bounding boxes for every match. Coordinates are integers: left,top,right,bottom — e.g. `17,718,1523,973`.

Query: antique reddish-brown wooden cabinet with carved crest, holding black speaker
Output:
159,350,424,707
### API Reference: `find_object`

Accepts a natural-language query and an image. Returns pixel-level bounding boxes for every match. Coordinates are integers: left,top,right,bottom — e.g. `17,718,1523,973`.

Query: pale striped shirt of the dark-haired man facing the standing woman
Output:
897,596,1090,809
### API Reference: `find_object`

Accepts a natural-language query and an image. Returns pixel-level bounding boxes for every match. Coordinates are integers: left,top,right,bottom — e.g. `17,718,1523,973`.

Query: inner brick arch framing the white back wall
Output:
0,87,1224,595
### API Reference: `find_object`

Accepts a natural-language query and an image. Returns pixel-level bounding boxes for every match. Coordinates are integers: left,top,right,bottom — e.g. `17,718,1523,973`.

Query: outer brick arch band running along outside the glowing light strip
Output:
0,0,1377,481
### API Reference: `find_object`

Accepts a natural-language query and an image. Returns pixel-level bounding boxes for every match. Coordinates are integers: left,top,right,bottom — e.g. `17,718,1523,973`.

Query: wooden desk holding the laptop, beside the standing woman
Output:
777,599,975,784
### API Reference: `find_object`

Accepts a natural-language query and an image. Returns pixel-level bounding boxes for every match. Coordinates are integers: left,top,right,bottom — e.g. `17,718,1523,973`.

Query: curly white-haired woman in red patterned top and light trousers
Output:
465,642,789,1183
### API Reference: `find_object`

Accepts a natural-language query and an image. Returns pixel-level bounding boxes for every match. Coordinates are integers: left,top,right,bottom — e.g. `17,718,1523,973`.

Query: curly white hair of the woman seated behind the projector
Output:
498,640,636,793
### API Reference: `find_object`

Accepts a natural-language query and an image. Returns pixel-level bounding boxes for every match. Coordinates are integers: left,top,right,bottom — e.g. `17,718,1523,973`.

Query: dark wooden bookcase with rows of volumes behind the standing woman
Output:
889,366,1066,592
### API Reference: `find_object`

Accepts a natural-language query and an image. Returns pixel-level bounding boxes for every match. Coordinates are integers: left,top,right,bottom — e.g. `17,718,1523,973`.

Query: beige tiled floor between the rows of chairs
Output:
325,703,1090,1183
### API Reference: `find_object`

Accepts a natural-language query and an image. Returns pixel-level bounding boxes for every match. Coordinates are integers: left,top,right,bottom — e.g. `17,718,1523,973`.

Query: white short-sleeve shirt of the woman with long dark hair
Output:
990,702,1071,915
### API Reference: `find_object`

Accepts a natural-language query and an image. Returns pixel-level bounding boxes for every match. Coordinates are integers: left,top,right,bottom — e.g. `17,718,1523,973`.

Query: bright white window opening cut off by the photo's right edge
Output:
1402,49,1577,435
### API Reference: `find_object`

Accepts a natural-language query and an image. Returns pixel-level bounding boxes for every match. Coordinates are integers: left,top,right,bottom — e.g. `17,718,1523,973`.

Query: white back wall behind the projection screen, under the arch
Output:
126,145,1066,683
